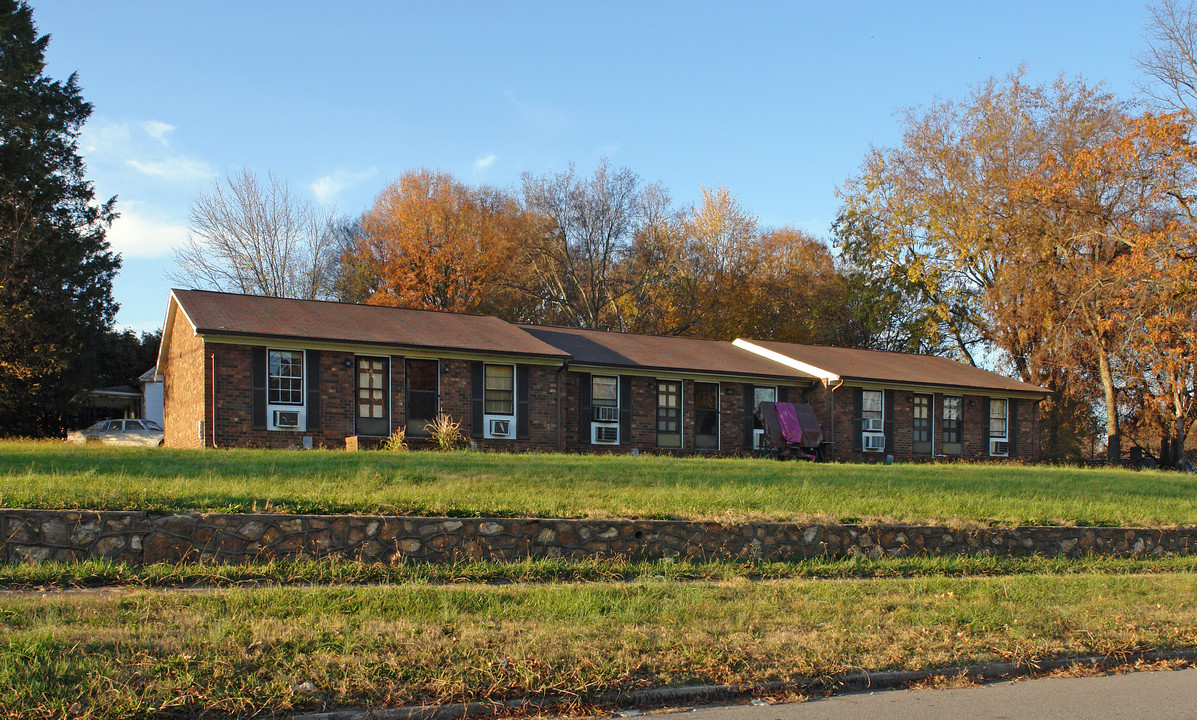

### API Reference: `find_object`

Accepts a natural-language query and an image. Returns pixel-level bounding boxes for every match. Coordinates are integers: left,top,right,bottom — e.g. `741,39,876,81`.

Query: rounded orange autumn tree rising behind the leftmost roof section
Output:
356,169,523,315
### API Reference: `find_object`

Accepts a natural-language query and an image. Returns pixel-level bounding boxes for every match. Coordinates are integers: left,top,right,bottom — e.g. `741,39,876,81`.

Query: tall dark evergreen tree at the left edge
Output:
0,0,121,435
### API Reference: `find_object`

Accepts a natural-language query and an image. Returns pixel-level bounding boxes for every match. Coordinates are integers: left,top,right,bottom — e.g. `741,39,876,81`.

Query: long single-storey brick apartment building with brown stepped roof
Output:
158,289,1046,462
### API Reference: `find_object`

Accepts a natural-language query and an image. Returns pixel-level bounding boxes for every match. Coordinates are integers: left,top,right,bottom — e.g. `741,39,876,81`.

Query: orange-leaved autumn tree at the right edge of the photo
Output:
1015,114,1197,458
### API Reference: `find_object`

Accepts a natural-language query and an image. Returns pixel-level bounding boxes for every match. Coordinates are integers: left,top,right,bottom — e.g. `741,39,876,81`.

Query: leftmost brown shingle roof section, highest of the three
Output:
172,289,569,360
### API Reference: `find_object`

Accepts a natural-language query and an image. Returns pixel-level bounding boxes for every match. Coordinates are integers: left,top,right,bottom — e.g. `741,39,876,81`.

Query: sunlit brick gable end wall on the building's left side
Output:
163,312,207,447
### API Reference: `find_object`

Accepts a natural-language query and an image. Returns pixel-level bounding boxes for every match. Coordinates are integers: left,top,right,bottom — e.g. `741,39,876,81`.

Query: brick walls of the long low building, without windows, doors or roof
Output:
164,315,1039,462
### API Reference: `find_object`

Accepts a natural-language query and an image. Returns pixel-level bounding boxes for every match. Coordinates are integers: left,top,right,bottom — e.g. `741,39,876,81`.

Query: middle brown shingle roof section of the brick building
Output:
519,325,812,380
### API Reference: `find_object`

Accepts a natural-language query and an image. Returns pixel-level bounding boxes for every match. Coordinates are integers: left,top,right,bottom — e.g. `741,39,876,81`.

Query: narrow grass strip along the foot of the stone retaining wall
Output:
0,555,1197,591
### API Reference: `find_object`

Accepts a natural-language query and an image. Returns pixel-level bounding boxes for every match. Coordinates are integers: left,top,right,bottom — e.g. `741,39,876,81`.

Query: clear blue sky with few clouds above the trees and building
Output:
34,0,1147,330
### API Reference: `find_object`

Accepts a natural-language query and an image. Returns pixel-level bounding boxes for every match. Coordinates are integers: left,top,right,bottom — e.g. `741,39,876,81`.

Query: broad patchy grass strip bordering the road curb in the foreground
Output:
0,573,1197,719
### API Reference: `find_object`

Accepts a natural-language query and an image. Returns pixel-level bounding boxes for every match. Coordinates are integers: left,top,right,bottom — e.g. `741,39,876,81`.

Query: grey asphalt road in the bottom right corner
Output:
645,667,1197,720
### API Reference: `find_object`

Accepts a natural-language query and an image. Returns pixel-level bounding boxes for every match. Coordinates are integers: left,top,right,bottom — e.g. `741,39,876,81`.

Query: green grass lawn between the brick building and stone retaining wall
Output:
0,441,1197,526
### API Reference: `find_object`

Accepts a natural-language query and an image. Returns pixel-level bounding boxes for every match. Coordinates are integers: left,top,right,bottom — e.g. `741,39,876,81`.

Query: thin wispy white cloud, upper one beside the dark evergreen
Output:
79,120,215,183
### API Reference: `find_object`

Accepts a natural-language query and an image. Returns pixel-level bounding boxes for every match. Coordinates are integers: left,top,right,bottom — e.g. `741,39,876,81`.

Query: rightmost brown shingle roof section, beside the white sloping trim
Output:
749,340,1049,395
